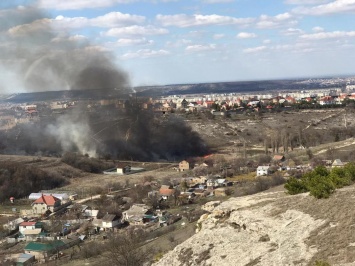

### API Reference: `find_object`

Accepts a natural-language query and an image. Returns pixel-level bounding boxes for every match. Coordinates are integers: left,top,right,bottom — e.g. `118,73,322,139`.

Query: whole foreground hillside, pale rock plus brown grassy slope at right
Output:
155,186,355,266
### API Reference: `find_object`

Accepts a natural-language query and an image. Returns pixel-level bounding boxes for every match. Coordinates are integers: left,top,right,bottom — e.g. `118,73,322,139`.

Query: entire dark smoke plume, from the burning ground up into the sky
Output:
0,4,207,160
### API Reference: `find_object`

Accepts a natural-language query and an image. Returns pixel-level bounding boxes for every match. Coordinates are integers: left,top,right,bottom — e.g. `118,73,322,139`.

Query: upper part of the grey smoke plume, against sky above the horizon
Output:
0,7,129,92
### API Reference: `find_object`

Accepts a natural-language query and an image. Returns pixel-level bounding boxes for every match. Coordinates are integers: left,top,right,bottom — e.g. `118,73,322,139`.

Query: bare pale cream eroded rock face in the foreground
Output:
155,192,324,266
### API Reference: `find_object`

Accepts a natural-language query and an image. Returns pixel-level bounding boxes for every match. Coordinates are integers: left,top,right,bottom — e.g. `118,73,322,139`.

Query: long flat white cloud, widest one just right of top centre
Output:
156,14,254,28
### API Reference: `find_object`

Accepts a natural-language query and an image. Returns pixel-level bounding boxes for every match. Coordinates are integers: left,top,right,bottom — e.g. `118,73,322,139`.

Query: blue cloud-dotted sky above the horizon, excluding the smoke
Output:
0,0,355,90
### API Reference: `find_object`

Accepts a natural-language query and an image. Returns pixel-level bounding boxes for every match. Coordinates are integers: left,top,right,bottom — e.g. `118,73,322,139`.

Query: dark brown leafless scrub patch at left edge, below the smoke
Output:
0,162,67,201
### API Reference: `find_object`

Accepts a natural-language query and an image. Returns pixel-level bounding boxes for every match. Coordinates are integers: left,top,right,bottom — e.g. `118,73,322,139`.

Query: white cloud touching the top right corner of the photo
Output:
293,0,355,16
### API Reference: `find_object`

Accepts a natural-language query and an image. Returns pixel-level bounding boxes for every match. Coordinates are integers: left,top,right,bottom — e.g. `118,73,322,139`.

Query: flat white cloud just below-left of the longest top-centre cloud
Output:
103,25,169,37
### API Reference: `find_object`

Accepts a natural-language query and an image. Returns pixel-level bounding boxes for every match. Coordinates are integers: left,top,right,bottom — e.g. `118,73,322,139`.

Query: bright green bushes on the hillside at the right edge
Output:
285,163,355,199
